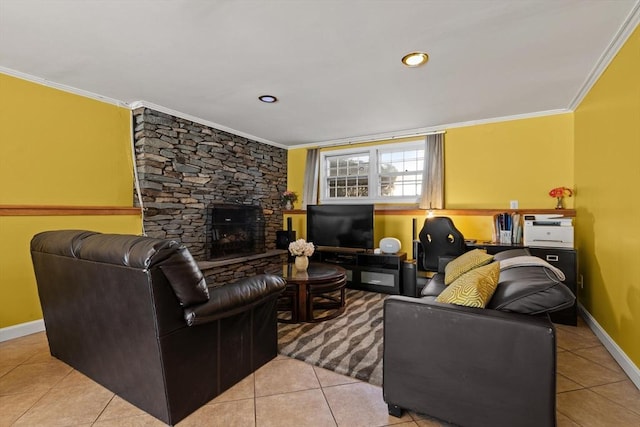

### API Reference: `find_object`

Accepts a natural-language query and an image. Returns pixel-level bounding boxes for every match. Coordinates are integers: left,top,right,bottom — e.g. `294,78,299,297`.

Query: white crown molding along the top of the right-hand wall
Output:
568,0,640,111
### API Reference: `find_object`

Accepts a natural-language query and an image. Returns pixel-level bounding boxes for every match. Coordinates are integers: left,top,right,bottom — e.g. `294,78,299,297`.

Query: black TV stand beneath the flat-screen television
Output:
311,248,407,295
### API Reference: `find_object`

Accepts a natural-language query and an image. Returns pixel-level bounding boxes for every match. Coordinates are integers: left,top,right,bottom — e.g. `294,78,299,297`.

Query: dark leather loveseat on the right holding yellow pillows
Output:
383,249,575,427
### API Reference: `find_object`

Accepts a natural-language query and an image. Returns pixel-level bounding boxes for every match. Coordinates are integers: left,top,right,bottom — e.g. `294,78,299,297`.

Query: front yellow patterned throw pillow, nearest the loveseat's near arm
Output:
436,262,500,308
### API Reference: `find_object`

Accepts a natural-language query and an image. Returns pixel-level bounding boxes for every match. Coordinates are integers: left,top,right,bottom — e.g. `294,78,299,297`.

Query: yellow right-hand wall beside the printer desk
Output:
575,28,640,367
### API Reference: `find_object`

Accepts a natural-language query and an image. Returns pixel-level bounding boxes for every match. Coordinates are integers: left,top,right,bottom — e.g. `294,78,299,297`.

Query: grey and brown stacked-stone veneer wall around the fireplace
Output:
133,108,287,284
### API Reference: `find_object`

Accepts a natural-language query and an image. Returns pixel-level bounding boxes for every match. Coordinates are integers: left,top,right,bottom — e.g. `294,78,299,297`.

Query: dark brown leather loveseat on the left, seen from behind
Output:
31,230,286,425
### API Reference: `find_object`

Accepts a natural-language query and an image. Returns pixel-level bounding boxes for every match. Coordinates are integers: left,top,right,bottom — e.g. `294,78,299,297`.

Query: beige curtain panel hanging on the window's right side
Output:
419,133,444,209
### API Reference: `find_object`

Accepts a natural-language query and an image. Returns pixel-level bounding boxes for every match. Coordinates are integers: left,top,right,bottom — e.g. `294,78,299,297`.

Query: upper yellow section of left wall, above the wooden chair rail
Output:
0,74,133,206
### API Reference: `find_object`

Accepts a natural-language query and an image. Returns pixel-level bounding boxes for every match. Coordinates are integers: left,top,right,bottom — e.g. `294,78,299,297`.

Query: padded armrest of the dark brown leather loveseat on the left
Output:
184,274,287,326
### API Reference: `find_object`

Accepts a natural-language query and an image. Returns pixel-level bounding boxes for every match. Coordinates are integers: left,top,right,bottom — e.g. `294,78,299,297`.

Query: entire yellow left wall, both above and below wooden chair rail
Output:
0,74,141,328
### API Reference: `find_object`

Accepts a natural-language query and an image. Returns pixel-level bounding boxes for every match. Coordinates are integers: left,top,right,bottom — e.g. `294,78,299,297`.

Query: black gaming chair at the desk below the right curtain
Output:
416,216,466,271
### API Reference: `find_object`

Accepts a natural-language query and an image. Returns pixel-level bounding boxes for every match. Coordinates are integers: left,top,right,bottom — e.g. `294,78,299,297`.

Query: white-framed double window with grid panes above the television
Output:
320,141,424,203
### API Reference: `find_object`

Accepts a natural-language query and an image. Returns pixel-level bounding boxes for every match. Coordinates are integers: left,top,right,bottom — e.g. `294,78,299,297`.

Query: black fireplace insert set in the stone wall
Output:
207,204,265,259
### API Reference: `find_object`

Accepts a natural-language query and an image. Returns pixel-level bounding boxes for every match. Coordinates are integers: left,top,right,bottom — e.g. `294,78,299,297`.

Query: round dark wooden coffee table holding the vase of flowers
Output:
267,262,347,323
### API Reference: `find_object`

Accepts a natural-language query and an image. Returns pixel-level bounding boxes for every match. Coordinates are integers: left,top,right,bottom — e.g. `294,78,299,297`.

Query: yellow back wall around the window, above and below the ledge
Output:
285,113,574,247
